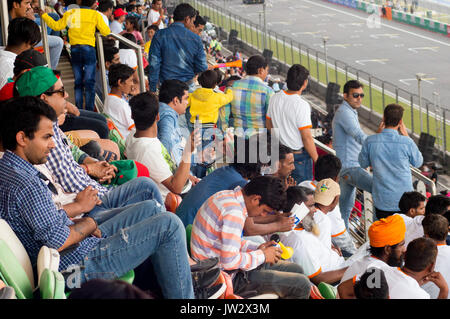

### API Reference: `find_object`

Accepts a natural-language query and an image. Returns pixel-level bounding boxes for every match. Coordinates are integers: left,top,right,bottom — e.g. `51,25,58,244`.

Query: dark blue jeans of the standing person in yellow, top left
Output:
71,45,97,111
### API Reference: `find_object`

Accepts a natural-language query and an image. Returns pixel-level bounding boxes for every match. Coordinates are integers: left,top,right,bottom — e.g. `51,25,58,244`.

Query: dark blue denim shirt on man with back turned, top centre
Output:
149,22,208,92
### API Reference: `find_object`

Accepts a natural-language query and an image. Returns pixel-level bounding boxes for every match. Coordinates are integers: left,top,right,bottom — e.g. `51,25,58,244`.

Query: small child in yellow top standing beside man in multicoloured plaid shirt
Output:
188,70,233,178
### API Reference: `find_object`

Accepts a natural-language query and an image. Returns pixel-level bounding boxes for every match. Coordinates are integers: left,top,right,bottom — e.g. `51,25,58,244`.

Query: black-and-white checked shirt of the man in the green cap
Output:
46,122,108,197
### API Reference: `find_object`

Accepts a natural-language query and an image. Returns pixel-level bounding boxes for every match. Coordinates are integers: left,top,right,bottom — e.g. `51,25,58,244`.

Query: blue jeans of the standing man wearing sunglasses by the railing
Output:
339,167,372,229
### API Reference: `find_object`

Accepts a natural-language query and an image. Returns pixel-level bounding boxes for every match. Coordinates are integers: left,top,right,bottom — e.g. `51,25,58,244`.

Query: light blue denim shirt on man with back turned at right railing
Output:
359,129,423,212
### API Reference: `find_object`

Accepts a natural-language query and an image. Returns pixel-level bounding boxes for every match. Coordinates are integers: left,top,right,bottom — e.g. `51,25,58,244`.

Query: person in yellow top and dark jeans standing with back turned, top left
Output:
39,0,111,111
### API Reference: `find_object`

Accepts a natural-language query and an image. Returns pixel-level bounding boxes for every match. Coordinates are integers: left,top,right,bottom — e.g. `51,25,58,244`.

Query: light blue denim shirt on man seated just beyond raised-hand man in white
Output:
158,102,183,165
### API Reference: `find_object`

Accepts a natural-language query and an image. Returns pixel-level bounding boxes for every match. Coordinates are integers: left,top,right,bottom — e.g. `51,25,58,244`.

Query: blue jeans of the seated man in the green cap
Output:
89,177,164,225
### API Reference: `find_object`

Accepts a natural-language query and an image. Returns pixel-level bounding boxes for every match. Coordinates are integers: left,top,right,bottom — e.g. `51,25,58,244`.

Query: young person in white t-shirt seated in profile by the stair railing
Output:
104,63,134,139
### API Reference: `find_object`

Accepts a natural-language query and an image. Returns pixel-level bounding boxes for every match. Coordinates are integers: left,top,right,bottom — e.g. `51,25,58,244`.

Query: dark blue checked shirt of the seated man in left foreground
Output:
0,151,101,271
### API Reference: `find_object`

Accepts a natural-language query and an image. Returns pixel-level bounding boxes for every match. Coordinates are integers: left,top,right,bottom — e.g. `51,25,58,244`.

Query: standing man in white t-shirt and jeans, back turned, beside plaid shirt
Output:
266,64,318,184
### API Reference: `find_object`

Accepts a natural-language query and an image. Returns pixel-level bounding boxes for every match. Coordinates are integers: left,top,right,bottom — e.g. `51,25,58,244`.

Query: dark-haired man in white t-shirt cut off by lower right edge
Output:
421,214,450,299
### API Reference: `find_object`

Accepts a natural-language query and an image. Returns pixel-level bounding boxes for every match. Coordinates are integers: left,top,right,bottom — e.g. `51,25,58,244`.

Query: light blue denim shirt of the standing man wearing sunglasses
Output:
332,101,367,169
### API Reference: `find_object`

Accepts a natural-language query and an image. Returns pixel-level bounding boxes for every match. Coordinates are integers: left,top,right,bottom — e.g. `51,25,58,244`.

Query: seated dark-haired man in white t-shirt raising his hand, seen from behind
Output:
126,92,194,205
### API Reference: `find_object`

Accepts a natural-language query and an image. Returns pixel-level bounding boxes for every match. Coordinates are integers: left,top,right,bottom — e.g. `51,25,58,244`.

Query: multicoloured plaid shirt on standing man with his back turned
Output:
230,76,274,130
